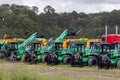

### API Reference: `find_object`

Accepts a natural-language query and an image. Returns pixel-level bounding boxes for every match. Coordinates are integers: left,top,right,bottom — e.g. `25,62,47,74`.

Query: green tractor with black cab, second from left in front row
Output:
22,41,44,64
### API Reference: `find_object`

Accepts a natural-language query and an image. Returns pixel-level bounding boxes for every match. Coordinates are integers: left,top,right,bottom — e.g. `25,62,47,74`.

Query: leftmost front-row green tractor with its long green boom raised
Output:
0,33,37,61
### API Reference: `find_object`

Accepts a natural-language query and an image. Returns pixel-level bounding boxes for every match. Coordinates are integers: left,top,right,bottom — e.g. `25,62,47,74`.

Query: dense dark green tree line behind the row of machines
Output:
0,4,120,38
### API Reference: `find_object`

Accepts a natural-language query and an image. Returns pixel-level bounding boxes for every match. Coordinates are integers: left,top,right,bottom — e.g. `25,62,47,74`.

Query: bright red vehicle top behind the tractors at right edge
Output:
101,34,120,44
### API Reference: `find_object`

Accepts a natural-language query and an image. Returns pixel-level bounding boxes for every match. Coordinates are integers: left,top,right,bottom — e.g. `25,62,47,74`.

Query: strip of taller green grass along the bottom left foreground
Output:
0,70,97,80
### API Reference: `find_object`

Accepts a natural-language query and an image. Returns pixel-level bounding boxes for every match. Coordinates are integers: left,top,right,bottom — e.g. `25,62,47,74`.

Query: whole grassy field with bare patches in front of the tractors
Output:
0,60,120,80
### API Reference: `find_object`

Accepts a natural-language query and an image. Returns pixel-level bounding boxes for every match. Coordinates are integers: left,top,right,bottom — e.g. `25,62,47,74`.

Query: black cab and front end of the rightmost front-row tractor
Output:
98,43,112,69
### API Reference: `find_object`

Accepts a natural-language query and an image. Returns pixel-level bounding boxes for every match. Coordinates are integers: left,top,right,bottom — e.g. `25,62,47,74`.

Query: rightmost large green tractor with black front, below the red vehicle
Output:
91,43,120,69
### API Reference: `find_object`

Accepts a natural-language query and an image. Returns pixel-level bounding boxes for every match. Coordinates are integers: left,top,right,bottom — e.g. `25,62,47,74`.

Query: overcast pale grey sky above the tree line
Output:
0,0,120,13
